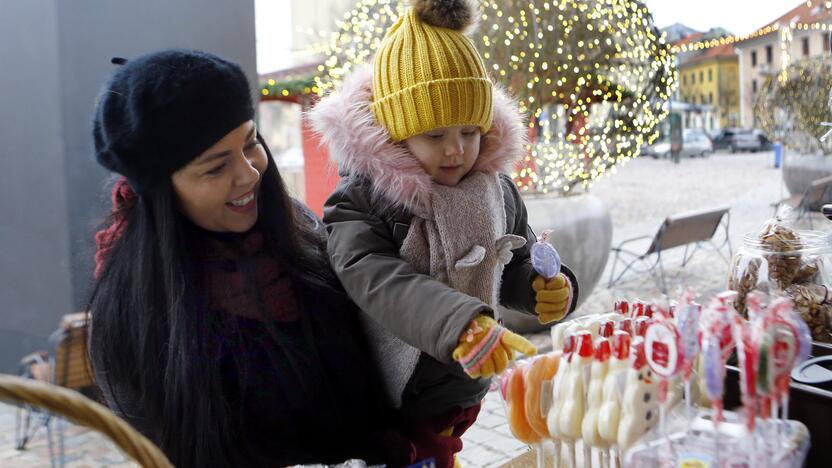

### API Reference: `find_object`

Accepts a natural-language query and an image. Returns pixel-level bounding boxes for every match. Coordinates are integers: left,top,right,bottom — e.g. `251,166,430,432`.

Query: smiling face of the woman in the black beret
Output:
171,120,269,232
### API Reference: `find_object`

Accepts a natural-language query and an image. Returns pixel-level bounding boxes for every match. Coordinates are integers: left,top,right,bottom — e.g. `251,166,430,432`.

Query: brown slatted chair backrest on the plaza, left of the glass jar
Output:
645,207,730,255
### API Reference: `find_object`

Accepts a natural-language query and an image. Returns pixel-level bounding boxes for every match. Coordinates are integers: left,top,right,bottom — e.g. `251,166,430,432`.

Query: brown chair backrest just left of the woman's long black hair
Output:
50,313,95,390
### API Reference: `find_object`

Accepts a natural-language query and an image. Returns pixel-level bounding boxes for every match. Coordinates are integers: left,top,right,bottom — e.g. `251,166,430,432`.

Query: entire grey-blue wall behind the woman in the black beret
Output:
0,0,257,372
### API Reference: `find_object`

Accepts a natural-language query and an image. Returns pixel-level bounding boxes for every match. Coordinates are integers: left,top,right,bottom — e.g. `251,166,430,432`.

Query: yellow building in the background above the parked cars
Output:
679,44,740,129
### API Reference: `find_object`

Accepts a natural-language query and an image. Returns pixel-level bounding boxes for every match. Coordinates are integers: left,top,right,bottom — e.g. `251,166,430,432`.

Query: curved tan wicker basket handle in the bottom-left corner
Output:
0,374,173,468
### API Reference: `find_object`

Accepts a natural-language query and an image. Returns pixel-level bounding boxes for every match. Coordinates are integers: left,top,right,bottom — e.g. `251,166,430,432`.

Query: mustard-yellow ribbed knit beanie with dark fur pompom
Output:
372,0,492,141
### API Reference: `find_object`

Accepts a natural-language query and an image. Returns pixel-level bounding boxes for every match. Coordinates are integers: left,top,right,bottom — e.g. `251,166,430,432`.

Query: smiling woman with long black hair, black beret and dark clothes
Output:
89,50,412,466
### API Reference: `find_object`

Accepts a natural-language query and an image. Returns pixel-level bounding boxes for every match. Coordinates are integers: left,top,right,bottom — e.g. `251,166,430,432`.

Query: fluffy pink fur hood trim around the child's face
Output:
308,66,528,213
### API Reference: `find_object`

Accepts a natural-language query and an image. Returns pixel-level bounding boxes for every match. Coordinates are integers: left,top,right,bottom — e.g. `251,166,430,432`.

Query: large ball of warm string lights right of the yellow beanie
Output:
477,0,676,192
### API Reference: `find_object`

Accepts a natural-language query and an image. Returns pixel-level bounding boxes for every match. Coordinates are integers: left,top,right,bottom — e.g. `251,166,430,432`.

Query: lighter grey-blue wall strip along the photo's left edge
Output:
0,0,72,372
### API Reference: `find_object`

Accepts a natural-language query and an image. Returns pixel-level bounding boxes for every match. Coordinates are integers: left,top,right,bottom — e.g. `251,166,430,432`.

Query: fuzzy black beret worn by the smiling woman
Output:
93,49,254,193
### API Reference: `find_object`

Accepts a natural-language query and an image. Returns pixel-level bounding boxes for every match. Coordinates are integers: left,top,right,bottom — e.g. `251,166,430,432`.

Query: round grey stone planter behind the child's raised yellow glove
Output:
503,194,612,333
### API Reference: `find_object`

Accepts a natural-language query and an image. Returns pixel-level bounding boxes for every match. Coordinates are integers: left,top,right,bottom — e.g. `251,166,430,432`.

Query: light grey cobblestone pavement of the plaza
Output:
0,152,832,467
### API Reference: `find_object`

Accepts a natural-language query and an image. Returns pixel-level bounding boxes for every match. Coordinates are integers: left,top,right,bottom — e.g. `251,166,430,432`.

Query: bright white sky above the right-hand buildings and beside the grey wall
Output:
254,0,817,73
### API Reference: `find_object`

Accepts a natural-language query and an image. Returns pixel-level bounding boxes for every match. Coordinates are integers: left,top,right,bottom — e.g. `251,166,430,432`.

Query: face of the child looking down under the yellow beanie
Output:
404,125,480,186
